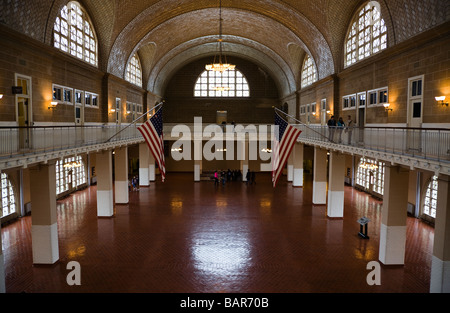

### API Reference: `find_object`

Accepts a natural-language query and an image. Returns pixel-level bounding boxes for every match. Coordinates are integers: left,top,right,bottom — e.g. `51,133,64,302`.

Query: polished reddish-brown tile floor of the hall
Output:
2,174,434,293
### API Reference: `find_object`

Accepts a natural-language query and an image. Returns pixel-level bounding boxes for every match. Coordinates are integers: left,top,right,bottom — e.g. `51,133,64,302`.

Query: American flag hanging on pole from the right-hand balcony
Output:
272,112,302,187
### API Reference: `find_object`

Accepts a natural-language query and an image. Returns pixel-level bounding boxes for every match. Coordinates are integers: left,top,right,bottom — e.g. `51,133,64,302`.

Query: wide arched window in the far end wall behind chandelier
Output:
194,69,250,97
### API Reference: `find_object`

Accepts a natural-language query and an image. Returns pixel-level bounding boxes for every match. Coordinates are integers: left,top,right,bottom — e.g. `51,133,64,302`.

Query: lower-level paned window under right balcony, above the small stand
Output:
356,158,385,195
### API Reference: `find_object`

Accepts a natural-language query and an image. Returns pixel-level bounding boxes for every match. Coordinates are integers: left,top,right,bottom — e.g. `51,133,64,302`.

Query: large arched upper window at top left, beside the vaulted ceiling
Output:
53,1,97,66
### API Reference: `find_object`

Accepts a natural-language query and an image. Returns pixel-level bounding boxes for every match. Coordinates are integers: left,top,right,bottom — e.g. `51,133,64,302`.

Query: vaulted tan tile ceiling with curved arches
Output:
0,0,450,95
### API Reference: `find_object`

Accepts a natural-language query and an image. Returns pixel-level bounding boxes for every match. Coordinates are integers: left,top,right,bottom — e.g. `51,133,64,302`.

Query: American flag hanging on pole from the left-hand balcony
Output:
138,108,166,182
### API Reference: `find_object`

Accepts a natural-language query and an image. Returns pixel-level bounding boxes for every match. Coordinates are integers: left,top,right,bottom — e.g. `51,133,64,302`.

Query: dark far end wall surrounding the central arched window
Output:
164,57,279,124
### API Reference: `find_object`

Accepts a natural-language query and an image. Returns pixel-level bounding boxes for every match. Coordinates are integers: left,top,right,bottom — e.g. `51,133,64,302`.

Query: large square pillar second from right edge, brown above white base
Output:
379,166,409,265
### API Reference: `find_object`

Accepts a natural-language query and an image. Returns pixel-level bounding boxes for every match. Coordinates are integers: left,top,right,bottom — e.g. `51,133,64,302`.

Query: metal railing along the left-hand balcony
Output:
0,125,142,158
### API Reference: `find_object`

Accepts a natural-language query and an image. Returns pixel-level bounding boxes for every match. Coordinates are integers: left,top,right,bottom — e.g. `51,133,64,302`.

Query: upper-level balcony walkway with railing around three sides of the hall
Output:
0,124,450,175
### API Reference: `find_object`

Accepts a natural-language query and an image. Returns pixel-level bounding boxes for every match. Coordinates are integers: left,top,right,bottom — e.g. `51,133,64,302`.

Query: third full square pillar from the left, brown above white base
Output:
114,147,129,204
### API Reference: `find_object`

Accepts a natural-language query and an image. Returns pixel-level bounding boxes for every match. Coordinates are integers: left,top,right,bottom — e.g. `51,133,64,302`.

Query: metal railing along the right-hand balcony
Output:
296,125,450,162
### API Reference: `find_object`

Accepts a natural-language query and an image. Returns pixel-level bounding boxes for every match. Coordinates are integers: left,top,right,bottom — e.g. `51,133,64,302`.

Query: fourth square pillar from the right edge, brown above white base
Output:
312,147,327,204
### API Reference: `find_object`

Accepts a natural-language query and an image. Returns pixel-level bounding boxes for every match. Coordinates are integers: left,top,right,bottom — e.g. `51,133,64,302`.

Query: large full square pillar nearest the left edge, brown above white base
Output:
30,164,59,265
